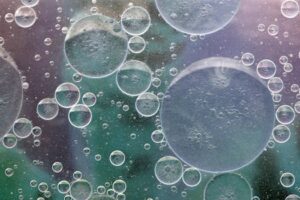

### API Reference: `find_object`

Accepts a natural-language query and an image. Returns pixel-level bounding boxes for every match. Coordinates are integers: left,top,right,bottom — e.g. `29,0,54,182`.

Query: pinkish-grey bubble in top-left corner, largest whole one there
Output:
15,6,37,28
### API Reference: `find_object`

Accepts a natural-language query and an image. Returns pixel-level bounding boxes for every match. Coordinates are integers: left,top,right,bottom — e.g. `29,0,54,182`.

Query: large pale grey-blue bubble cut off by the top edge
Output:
155,0,240,35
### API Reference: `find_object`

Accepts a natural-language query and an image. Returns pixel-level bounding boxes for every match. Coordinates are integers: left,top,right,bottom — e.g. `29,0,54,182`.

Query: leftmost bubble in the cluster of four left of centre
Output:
36,98,59,120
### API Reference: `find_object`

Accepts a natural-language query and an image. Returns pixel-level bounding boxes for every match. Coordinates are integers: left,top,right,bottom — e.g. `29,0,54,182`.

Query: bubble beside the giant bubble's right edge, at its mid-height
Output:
276,105,295,125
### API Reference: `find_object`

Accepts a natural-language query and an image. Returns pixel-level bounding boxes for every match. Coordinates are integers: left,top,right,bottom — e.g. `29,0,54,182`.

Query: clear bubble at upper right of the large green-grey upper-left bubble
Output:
121,6,151,35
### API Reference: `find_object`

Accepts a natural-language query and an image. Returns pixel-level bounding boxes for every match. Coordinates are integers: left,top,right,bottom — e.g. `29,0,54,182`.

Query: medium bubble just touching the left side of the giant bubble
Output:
135,92,160,117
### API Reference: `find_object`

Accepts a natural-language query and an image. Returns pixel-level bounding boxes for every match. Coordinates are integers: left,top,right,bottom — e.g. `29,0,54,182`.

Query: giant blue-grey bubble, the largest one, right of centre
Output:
160,58,275,172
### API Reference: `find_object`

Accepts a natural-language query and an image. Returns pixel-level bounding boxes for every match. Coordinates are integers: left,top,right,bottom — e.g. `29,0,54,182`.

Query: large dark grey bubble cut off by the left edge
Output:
0,48,23,137
